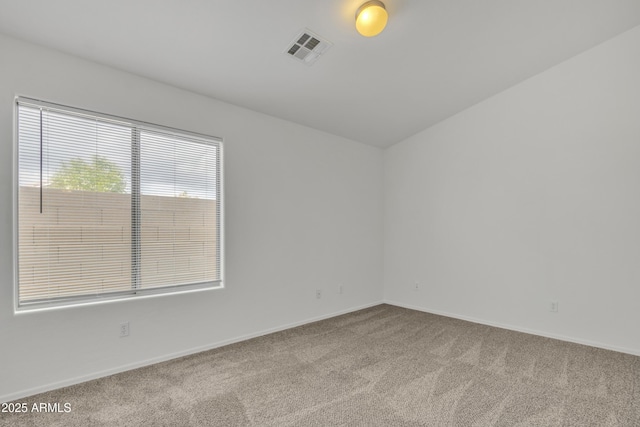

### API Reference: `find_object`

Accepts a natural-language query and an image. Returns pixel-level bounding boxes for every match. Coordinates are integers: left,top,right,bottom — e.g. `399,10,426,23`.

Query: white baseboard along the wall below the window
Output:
0,301,383,402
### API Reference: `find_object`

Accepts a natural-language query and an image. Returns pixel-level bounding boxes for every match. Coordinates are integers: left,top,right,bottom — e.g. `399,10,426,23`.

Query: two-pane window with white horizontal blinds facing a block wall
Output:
16,98,223,308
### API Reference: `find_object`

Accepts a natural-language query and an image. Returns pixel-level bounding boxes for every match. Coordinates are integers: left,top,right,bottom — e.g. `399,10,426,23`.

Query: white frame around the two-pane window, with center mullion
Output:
12,96,225,313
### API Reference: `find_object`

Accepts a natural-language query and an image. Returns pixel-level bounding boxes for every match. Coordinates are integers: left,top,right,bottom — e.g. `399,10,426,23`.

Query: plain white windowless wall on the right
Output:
384,27,640,354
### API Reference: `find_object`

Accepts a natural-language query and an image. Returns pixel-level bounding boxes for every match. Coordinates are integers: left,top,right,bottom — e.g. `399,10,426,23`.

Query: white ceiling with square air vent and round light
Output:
0,0,640,147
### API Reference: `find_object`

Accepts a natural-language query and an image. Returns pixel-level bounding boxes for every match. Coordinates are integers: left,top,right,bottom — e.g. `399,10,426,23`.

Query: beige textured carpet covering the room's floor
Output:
0,305,640,427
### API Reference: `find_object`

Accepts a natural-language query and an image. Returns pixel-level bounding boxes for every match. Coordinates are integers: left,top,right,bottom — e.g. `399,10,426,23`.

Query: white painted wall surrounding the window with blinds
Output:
0,36,383,401
